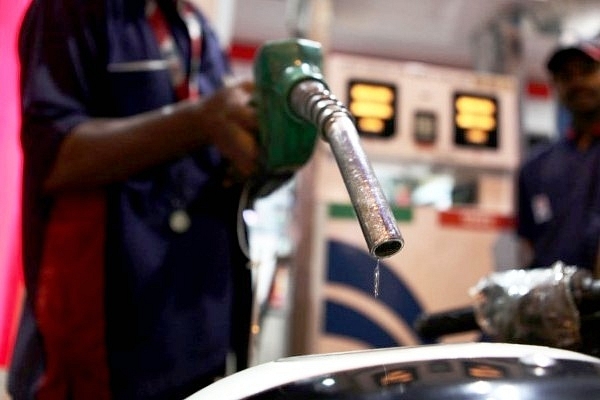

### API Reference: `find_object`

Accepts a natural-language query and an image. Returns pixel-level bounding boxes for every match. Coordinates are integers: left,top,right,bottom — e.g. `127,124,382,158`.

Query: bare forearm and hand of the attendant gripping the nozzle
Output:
44,82,258,193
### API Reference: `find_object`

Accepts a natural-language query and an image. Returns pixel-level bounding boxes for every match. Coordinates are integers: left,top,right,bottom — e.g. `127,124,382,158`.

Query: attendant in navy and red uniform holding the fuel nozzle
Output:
8,0,259,400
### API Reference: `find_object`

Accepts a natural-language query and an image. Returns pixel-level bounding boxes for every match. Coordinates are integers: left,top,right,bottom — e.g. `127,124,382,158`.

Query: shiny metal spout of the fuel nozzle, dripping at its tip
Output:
289,79,404,258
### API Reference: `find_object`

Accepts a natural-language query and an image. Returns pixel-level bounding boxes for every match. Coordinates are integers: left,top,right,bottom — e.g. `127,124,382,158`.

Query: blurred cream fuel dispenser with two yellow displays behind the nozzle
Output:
268,53,519,354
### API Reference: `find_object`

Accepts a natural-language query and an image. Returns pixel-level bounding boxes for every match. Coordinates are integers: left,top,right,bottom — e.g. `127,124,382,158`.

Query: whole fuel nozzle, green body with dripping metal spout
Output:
254,39,404,258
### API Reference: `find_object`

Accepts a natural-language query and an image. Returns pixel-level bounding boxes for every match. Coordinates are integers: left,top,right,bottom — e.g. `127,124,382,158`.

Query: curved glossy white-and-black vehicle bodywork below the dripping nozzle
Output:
187,343,600,400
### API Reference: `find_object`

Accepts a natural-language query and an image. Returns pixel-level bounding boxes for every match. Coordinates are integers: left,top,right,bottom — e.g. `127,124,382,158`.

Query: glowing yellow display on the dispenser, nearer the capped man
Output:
454,93,499,149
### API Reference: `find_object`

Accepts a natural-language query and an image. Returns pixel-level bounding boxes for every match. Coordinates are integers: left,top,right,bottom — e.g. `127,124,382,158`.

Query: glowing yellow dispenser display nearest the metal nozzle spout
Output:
348,80,397,137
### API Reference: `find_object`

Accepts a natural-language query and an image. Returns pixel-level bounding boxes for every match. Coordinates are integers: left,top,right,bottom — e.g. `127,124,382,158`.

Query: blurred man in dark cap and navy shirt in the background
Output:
517,40,600,276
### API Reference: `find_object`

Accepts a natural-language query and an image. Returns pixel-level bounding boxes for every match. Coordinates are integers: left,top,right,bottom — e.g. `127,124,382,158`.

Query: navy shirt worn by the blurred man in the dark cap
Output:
517,138,600,269
